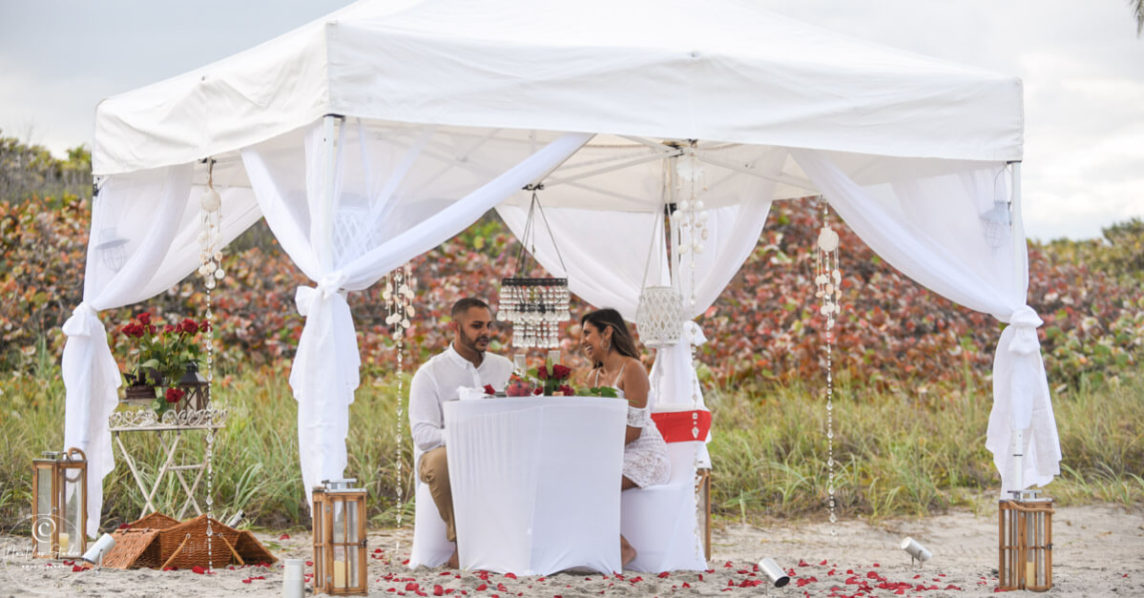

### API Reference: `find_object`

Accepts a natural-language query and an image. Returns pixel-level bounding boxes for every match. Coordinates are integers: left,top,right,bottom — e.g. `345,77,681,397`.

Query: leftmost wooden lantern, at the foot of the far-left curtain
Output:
32,448,87,558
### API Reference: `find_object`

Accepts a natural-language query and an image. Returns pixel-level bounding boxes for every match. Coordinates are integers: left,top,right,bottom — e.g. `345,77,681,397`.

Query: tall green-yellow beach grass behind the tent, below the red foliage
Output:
0,362,1144,533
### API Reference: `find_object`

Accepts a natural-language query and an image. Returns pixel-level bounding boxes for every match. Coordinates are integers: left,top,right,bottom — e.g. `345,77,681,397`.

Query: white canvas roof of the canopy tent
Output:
93,0,1023,175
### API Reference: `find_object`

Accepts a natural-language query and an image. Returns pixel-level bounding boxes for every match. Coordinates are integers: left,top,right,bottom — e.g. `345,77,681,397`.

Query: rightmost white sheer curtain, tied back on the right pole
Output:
792,150,1060,496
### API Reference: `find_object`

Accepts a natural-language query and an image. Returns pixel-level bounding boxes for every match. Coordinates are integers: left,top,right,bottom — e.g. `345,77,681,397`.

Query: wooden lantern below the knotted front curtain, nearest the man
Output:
312,478,368,596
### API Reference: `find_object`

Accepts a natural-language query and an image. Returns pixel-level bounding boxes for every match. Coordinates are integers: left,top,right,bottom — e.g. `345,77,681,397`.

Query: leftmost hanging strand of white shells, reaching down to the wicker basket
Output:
199,159,227,571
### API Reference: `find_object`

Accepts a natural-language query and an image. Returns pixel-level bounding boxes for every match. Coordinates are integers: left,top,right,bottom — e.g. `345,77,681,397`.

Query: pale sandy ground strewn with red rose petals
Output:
0,505,1144,598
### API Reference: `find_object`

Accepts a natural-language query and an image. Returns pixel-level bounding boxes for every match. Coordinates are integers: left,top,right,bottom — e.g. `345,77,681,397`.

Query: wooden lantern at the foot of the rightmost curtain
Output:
998,491,1052,592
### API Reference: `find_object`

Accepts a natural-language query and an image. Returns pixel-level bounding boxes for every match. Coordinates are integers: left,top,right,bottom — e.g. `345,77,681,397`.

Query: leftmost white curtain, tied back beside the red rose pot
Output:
61,165,259,536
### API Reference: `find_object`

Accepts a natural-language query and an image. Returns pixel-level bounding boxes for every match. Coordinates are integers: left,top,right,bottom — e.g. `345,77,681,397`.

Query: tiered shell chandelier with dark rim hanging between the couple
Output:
496,185,572,350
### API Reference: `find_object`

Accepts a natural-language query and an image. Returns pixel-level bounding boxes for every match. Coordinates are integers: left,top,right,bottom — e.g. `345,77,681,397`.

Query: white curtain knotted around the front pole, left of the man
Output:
236,120,591,497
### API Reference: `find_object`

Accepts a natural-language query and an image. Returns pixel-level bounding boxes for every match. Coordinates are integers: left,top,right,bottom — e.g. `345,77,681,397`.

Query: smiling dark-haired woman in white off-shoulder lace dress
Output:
580,309,670,566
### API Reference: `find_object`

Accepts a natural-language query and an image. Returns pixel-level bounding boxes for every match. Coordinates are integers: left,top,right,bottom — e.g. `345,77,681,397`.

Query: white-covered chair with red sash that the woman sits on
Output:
620,410,710,573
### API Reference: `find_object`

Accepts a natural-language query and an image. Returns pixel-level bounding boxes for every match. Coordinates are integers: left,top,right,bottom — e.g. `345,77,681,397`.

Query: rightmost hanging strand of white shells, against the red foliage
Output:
815,201,842,535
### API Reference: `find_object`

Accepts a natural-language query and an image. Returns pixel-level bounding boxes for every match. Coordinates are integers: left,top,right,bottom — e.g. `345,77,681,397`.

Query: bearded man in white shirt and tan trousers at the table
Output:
410,297,513,568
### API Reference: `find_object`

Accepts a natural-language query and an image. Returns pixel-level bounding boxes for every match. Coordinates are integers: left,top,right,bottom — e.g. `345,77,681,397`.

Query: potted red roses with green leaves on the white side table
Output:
112,312,209,416
